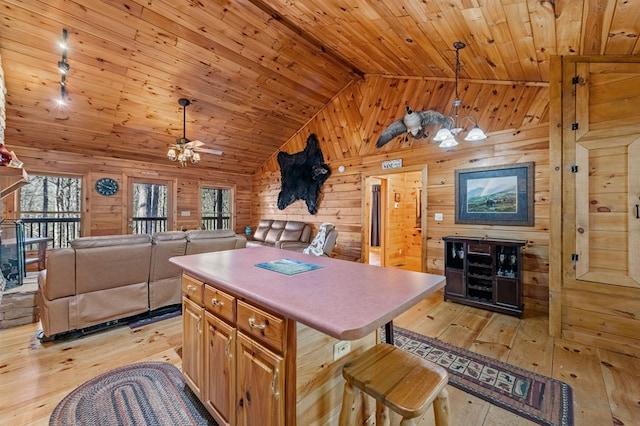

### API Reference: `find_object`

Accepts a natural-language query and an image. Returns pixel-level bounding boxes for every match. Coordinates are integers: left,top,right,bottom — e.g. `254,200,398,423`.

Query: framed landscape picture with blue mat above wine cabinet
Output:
455,162,534,226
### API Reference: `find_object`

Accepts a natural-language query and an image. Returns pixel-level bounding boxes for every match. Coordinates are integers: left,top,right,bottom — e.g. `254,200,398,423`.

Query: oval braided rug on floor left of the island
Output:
49,362,216,426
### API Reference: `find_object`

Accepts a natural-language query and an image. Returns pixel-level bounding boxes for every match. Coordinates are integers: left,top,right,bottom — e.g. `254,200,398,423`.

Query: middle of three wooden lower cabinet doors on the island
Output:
202,312,236,426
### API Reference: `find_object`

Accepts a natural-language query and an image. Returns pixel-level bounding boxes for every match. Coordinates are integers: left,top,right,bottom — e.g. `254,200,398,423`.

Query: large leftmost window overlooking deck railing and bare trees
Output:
20,175,82,248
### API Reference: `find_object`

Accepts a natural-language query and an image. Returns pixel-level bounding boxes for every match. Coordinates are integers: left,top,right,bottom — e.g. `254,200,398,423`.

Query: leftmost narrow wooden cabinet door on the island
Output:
182,297,204,398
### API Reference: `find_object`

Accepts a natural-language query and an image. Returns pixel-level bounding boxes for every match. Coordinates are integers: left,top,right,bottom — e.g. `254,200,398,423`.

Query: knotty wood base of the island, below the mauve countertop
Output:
182,273,376,426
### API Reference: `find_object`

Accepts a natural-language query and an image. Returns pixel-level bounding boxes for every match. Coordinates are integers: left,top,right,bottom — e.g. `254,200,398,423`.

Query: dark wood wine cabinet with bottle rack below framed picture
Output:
442,236,526,317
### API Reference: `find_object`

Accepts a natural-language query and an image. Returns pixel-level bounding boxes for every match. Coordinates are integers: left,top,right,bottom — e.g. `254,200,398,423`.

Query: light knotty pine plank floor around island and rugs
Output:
0,293,640,426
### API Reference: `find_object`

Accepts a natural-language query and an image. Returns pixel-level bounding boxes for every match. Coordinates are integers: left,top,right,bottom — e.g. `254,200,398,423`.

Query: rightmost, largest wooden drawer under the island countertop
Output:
237,300,286,353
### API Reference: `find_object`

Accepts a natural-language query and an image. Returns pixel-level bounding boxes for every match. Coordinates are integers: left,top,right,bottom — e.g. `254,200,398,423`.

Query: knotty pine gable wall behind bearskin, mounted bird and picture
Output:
251,76,549,311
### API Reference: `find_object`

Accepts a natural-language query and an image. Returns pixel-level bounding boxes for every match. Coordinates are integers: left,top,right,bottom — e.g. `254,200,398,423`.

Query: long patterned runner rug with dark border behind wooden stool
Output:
393,326,573,426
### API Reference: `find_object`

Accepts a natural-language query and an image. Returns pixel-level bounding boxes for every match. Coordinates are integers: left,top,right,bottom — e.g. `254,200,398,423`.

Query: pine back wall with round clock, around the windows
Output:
2,148,251,236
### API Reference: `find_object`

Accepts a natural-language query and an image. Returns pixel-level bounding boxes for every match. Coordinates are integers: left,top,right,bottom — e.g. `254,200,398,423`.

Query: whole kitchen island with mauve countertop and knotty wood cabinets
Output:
171,247,444,426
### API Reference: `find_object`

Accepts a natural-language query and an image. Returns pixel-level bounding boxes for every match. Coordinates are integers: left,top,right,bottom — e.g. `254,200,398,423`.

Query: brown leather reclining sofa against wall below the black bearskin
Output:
247,219,311,248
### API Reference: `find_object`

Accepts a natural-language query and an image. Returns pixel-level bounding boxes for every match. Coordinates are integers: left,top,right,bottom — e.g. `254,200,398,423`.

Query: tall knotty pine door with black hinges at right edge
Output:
552,57,640,354
